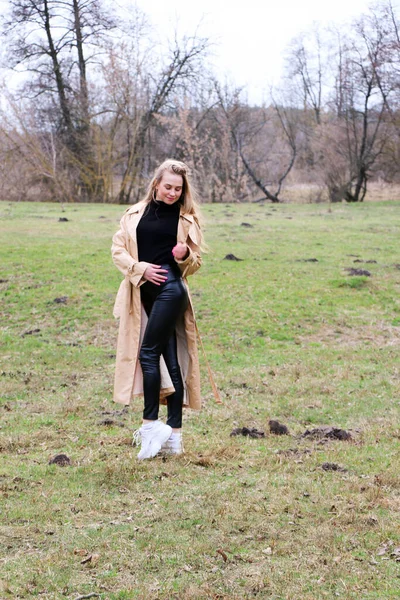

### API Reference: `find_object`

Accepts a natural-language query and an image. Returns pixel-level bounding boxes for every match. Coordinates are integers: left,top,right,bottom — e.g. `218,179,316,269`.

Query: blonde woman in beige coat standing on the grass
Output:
111,160,202,460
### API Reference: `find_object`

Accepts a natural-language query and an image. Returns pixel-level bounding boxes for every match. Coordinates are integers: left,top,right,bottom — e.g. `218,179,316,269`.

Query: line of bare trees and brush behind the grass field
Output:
0,0,400,204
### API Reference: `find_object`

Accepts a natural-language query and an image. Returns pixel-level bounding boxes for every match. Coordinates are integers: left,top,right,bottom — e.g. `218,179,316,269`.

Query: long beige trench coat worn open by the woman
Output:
111,202,201,410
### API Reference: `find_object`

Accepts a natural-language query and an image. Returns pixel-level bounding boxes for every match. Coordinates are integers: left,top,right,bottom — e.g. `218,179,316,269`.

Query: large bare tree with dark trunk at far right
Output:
296,11,394,202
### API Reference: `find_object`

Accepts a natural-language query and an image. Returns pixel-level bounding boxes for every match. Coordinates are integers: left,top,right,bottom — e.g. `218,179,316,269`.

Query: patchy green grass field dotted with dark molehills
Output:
0,202,400,600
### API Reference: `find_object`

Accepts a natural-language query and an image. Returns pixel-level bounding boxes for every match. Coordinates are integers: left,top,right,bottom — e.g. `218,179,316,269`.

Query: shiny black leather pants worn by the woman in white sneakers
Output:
139,265,188,428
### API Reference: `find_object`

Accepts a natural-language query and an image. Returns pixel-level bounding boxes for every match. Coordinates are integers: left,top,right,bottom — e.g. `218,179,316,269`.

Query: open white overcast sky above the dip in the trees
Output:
130,0,400,103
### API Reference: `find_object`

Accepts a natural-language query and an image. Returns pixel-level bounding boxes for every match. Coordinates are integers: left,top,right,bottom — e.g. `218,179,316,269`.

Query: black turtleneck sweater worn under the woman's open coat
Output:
136,200,181,265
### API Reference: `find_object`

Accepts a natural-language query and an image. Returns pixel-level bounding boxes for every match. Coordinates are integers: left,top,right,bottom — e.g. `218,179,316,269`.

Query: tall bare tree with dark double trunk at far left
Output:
3,0,114,199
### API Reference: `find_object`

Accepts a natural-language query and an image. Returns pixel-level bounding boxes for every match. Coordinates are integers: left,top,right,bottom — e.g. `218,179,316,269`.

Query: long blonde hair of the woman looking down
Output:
143,158,204,249
